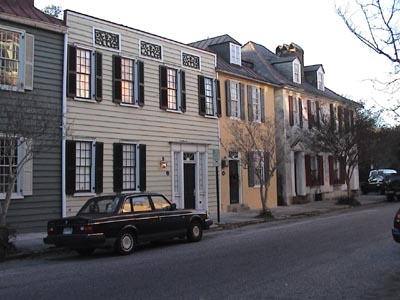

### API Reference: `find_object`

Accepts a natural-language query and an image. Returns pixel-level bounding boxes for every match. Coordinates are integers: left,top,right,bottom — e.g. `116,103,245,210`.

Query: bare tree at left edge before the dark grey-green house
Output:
0,91,61,227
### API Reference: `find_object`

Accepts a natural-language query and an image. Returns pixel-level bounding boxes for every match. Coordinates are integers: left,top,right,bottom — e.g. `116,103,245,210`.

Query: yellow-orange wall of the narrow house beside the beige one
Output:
218,72,277,211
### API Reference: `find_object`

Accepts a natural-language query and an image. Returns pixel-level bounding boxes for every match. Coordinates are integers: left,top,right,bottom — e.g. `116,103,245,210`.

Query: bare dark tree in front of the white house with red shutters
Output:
305,108,376,199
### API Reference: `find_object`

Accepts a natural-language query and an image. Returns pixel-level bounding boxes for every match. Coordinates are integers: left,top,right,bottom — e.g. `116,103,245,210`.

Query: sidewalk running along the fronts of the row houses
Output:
5,195,386,258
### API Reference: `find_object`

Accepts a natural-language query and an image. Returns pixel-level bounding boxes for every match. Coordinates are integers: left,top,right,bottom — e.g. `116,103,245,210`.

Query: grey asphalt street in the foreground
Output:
0,203,400,300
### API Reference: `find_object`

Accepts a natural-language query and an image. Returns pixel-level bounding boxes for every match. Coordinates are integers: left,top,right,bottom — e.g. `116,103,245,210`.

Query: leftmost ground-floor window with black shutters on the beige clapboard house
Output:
66,141,103,195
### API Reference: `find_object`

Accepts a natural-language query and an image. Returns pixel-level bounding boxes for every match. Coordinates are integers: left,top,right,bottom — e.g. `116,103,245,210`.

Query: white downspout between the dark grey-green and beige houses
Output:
61,31,68,218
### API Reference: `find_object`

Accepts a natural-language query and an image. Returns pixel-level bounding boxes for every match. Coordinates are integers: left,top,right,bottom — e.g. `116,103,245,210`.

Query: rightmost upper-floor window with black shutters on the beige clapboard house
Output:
198,75,221,117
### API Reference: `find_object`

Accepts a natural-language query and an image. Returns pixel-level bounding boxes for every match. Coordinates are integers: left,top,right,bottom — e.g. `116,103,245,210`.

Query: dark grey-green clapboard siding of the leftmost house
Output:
0,20,64,232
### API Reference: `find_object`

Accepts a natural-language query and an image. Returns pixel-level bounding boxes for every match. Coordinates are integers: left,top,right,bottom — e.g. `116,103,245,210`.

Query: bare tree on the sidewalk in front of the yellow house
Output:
223,117,277,217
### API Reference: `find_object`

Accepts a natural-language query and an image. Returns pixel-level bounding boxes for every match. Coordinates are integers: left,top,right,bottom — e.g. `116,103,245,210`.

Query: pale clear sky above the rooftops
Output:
35,0,393,122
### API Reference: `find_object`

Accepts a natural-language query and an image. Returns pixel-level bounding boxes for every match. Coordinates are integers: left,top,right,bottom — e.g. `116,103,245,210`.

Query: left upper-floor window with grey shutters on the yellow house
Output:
226,80,245,120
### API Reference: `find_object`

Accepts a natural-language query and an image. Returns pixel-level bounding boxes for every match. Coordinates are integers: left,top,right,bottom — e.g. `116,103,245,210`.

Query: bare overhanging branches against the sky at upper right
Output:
337,0,400,119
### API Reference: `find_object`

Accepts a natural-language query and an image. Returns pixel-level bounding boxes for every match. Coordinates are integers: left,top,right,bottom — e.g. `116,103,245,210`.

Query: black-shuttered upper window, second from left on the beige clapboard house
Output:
113,55,144,106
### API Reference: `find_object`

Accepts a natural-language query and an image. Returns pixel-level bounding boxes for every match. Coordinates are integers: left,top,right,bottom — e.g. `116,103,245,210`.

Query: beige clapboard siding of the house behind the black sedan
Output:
67,12,219,214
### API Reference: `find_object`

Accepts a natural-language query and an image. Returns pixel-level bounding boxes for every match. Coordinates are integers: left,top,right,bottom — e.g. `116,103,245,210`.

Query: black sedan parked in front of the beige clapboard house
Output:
44,193,213,255
